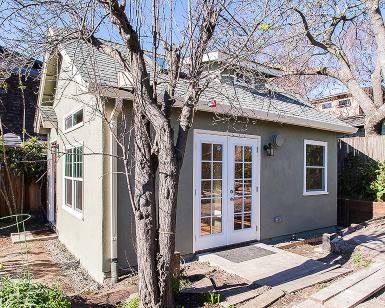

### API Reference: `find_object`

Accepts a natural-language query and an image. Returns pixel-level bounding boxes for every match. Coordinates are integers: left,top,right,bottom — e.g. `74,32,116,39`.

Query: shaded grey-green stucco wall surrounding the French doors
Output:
113,105,337,267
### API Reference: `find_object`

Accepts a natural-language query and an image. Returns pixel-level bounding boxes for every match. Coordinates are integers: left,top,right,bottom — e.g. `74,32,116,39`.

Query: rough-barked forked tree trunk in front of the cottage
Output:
88,0,223,308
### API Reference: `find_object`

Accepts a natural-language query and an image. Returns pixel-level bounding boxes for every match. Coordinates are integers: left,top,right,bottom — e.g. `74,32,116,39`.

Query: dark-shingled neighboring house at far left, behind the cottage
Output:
0,46,45,146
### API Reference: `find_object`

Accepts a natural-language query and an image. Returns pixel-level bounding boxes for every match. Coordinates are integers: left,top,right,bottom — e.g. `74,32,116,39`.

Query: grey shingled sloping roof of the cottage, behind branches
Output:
49,25,351,134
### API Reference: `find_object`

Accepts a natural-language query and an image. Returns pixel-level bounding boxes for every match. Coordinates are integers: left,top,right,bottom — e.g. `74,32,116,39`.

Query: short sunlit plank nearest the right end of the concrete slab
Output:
278,269,351,293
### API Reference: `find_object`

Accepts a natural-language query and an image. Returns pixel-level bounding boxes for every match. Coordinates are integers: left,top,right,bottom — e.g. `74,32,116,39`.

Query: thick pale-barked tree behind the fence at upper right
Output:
283,0,385,136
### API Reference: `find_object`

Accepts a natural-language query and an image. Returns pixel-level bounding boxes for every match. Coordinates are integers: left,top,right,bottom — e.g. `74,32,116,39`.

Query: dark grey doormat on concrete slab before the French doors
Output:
214,245,275,263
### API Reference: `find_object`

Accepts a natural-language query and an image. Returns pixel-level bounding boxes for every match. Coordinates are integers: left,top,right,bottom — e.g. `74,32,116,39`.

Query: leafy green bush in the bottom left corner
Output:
0,276,71,308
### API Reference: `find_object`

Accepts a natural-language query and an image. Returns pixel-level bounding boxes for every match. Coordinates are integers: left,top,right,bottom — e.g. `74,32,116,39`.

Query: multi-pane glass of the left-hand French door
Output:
200,143,223,235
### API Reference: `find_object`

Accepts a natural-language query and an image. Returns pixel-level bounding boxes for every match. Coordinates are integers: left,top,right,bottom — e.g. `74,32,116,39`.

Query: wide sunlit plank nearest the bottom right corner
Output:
325,268,385,308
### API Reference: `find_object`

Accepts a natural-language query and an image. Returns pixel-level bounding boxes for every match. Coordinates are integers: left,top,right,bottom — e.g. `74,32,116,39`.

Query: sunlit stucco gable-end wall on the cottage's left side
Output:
49,59,105,282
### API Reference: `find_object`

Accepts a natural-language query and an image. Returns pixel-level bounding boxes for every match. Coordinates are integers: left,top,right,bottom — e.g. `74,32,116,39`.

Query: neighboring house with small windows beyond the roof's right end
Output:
310,88,376,137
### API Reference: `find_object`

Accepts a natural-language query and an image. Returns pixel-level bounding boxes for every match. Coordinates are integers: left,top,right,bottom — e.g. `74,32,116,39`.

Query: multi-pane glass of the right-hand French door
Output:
233,145,253,230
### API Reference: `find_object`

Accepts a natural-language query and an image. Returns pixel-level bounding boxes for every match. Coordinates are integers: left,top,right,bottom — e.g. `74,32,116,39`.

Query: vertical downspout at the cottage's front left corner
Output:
110,98,123,283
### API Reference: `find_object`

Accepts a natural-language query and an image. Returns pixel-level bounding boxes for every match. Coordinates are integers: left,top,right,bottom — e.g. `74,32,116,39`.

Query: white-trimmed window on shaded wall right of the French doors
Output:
304,140,328,195
